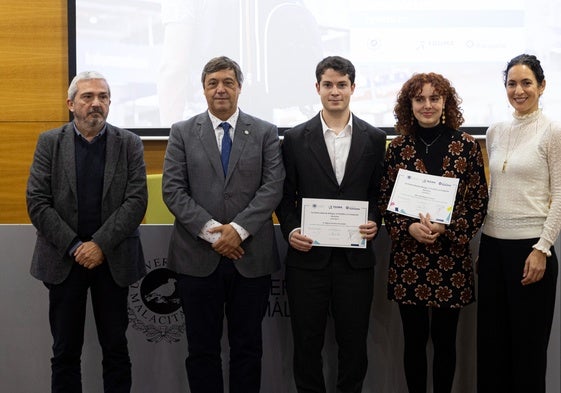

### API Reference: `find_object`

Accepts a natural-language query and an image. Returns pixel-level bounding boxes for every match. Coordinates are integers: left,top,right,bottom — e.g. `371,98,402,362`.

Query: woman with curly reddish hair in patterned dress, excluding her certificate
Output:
380,73,487,393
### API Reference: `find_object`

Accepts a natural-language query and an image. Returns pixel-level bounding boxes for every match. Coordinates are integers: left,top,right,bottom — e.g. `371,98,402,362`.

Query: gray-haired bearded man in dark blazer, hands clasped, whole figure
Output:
27,71,148,393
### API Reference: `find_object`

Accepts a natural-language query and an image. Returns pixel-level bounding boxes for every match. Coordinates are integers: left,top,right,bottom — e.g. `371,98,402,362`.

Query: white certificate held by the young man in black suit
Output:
301,198,368,248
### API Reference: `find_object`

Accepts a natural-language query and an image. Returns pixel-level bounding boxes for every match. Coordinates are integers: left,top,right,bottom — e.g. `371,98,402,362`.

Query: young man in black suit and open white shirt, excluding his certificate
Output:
277,56,386,393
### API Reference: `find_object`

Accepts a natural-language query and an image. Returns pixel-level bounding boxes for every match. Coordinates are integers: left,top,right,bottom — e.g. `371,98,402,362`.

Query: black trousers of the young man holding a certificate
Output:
286,250,374,393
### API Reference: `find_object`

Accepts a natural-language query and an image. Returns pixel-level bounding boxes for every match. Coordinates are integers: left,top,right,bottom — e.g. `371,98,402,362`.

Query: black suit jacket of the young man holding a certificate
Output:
276,114,386,269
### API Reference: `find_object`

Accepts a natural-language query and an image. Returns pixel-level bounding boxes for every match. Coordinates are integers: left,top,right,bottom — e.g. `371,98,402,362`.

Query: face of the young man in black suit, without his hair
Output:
316,68,355,113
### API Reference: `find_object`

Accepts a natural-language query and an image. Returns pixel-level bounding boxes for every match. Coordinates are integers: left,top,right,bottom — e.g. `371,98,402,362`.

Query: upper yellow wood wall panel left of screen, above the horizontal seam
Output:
0,0,68,122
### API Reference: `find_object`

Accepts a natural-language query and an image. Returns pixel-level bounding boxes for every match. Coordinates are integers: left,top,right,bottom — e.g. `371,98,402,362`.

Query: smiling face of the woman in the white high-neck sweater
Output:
506,64,545,115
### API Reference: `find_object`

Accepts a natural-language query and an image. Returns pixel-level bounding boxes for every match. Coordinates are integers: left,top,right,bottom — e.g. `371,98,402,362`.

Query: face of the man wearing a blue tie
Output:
203,69,242,120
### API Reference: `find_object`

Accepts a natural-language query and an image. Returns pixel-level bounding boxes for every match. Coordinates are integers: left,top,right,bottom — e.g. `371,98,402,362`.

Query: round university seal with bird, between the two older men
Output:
128,258,185,343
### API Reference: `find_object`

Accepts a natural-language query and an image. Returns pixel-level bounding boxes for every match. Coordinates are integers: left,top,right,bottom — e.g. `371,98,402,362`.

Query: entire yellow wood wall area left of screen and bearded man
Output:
0,0,68,220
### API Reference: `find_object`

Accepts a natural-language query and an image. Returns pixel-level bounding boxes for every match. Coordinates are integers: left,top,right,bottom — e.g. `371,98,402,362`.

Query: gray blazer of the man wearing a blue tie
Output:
162,111,284,277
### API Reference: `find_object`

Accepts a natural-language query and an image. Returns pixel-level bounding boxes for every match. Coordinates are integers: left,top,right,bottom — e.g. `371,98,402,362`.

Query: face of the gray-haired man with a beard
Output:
66,79,111,135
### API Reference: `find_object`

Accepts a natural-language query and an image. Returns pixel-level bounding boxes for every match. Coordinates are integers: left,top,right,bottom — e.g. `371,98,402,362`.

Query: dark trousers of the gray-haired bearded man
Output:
45,262,131,393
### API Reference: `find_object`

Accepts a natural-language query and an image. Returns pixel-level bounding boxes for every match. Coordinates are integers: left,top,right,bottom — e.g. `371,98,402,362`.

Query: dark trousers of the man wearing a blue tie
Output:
176,258,271,393
